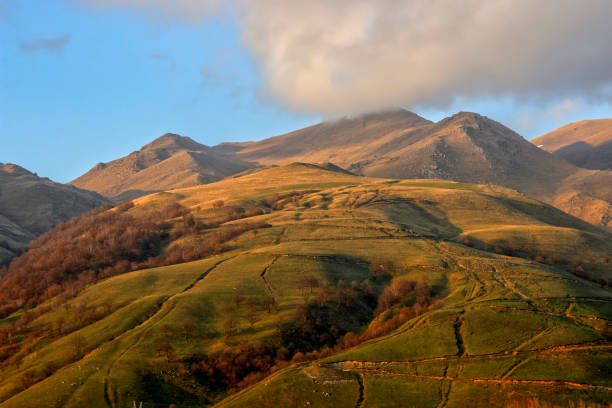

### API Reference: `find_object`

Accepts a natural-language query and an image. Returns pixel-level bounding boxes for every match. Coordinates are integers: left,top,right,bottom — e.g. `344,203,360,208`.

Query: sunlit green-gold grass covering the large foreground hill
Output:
0,164,612,408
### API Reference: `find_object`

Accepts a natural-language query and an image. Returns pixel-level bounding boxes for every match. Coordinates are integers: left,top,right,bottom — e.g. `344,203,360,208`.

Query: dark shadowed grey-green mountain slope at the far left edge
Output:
0,163,108,262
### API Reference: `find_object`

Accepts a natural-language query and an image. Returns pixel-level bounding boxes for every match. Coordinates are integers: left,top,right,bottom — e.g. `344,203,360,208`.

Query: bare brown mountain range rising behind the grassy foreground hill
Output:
72,109,612,227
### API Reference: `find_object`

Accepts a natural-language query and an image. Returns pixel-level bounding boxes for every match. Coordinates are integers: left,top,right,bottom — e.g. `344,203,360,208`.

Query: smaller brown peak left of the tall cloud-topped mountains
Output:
70,133,253,201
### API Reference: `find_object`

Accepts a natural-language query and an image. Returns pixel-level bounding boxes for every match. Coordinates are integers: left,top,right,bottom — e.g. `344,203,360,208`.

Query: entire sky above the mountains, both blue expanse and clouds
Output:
0,0,612,182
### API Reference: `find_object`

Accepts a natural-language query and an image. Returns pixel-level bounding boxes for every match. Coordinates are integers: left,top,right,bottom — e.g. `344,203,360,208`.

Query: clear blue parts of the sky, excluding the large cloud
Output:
0,0,612,182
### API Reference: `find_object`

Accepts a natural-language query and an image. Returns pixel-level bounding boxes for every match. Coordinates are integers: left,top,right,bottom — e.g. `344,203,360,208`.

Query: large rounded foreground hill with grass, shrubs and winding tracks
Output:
0,163,612,408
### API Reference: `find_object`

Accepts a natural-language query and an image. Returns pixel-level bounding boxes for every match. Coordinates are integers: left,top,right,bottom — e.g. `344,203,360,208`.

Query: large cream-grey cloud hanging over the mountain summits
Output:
80,0,612,115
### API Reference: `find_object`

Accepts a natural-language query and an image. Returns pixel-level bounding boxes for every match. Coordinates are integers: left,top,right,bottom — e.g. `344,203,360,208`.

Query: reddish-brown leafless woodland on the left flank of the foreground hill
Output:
0,202,268,316
